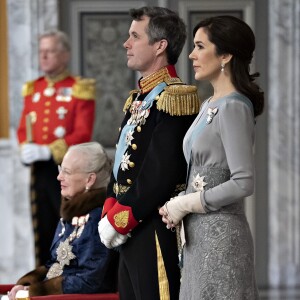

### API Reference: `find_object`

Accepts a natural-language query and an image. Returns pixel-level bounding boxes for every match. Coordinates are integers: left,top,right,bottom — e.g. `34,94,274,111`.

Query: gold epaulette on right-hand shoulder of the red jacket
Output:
72,77,96,100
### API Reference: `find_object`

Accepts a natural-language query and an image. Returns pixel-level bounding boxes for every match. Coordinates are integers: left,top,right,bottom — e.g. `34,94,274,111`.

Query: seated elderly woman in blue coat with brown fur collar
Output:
6,142,118,300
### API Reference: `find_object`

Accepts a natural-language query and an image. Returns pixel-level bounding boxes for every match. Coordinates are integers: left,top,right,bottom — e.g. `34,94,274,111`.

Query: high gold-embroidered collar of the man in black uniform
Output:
139,65,177,94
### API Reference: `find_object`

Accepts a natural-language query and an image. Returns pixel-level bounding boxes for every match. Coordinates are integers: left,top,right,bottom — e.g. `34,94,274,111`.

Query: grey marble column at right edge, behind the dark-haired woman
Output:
268,0,300,288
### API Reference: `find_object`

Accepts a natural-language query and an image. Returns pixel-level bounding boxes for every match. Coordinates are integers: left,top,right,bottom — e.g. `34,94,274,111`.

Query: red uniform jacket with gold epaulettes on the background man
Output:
17,72,95,164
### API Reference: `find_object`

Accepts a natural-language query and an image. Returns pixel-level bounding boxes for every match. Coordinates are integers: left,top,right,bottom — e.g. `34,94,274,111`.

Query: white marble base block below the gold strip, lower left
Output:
0,133,34,283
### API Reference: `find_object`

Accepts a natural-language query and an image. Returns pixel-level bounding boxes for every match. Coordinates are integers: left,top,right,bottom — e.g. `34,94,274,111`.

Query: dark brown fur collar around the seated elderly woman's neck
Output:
60,188,106,221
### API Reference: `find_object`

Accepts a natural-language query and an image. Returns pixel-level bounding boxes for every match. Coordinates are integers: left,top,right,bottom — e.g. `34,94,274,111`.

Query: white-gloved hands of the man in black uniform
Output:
98,216,130,249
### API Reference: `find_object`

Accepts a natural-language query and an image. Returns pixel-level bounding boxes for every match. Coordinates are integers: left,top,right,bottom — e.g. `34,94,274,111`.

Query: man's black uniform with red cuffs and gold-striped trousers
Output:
104,66,198,300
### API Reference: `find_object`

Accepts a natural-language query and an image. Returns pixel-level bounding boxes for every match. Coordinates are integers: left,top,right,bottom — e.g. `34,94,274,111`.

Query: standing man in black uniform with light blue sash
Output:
98,7,199,300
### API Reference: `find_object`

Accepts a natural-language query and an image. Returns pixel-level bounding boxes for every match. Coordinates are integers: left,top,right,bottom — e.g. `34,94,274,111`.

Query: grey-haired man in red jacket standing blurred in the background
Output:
17,31,95,265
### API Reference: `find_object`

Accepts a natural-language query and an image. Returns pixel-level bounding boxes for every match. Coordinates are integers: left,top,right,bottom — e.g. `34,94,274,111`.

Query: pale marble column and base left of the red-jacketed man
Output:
0,0,58,284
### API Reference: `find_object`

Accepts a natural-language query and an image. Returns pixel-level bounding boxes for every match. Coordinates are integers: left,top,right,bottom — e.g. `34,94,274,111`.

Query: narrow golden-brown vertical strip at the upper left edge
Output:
0,0,9,138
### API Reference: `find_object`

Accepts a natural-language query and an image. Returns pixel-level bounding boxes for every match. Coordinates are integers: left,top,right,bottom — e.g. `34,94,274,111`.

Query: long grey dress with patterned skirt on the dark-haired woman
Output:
180,92,258,300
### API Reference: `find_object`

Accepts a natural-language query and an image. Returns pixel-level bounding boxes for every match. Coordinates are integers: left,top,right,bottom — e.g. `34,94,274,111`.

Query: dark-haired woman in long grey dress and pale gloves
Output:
159,16,264,300
